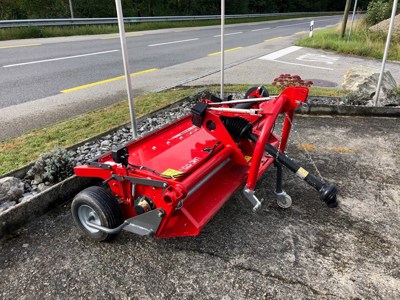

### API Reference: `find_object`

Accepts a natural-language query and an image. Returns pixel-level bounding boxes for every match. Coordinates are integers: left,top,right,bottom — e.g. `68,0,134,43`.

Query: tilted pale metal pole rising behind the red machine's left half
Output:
115,0,137,139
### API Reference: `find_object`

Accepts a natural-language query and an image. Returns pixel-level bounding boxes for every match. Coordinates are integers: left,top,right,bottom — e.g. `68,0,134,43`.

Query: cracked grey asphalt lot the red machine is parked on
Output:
0,113,400,300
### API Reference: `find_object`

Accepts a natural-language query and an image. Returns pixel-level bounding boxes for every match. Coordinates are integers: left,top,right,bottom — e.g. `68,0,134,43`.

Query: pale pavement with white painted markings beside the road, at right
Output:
190,36,400,89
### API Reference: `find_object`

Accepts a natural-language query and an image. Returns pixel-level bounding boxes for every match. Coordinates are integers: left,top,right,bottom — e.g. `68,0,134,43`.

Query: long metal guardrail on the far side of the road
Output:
0,11,343,28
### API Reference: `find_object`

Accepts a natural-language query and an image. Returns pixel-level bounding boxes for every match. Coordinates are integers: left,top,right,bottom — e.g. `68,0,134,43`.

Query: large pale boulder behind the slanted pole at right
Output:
343,66,400,106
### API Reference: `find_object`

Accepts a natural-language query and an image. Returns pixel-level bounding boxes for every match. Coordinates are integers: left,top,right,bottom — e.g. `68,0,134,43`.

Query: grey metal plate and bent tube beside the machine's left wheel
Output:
86,208,165,236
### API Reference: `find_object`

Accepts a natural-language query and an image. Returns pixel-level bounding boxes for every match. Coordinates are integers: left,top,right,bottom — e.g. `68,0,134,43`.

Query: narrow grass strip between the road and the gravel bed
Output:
0,85,344,174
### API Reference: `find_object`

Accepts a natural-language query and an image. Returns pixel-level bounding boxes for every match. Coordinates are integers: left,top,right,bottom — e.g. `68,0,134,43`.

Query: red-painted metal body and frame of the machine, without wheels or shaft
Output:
75,87,308,237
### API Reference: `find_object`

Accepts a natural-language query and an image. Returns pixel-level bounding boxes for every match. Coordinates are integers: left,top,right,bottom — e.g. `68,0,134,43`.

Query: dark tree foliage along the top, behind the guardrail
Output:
0,0,369,20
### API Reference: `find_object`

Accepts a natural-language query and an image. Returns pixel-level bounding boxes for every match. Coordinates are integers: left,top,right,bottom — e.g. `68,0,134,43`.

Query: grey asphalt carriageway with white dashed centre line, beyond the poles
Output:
0,16,340,108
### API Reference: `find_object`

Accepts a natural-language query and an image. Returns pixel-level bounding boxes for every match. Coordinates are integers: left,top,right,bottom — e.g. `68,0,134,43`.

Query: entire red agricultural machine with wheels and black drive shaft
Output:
72,86,338,241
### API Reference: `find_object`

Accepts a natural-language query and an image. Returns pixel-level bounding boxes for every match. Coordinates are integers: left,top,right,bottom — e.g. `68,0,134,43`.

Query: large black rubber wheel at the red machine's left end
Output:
71,186,123,242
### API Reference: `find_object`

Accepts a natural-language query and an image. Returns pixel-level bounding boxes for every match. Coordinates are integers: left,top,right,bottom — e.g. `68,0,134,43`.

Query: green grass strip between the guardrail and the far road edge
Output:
0,14,334,40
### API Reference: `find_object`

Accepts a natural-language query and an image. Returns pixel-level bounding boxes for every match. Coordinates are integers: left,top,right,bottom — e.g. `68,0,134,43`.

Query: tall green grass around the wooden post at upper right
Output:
296,22,400,61
